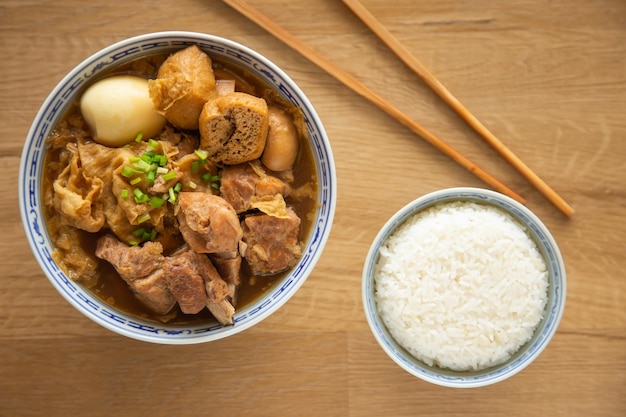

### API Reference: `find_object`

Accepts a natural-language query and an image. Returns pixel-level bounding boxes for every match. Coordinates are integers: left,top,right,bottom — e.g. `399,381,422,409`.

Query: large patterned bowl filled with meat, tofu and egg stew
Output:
19,32,336,344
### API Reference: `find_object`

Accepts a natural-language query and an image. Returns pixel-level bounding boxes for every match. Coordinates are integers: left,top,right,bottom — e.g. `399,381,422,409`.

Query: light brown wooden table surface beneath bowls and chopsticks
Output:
0,0,626,417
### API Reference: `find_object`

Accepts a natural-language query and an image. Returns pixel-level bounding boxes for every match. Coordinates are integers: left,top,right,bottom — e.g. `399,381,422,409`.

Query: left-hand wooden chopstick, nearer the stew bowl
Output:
224,0,525,204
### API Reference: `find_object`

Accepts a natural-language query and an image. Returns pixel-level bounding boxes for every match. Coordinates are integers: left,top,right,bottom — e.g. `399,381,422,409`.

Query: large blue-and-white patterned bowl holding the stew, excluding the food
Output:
19,32,337,344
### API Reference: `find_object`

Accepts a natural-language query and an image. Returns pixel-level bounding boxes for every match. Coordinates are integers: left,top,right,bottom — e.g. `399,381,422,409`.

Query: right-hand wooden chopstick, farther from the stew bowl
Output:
342,0,574,217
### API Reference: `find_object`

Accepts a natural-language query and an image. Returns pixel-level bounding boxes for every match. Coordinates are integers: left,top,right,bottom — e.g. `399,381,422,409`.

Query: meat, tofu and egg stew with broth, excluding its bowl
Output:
42,45,317,325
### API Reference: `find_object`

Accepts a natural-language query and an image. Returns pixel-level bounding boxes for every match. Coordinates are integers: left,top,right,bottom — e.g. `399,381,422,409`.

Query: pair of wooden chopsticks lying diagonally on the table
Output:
224,0,574,217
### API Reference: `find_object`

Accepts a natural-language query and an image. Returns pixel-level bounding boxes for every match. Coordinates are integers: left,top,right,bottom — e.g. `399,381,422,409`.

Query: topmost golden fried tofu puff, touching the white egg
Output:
148,45,216,130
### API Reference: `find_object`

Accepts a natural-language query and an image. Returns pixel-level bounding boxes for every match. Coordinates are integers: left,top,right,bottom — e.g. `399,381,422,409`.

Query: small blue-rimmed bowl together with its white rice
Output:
362,188,566,388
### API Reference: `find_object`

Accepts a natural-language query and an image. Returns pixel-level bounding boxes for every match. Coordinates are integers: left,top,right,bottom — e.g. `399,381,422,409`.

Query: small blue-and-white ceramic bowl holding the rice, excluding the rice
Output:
362,188,566,388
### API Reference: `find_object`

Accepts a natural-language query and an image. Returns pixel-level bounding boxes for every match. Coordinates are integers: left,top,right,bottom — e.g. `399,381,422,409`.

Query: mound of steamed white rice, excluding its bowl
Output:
375,202,548,371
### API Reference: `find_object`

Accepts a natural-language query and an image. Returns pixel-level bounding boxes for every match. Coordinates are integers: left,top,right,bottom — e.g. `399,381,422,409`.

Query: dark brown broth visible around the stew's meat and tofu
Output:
42,50,317,324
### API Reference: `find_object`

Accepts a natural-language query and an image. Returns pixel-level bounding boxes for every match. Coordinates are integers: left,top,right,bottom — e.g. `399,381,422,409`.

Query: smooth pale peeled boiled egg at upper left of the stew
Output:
80,75,165,147
